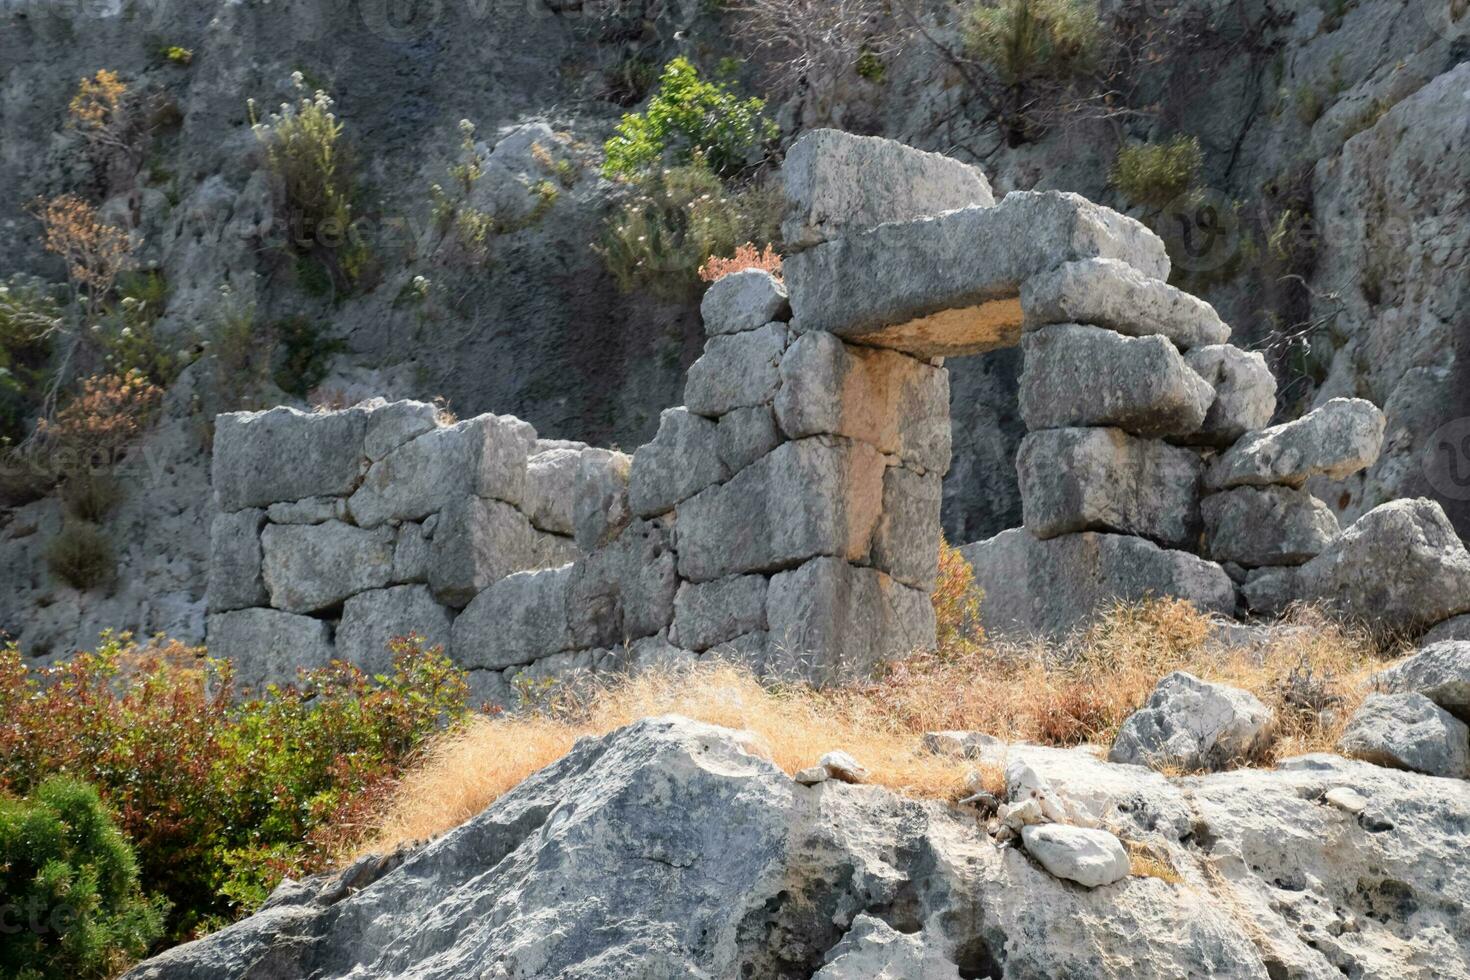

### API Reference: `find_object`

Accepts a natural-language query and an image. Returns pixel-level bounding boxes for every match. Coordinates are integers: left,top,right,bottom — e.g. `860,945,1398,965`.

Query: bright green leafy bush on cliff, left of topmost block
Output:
603,57,779,178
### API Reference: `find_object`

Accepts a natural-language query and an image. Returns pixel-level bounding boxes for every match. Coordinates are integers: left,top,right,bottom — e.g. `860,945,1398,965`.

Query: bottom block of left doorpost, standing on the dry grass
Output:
766,558,935,685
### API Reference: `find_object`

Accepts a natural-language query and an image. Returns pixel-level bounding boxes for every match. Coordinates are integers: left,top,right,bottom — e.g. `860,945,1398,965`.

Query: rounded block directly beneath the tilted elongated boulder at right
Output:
1200,486,1341,569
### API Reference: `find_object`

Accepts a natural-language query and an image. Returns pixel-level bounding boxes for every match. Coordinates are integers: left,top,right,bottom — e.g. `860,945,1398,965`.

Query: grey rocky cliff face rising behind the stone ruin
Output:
0,0,1470,652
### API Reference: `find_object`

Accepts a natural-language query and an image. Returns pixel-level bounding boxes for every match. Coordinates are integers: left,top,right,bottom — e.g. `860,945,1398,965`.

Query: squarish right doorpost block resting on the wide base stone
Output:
1016,429,1201,548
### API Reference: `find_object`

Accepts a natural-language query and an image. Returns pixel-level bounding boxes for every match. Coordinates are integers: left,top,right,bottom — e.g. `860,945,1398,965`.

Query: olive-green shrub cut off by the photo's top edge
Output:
964,0,1103,85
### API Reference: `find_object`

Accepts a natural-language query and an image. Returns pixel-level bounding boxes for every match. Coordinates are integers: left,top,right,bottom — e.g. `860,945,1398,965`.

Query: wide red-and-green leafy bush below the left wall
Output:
0,633,466,939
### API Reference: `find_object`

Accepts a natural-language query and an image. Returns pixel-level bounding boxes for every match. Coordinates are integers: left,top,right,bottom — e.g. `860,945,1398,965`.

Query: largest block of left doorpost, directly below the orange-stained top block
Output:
678,436,885,582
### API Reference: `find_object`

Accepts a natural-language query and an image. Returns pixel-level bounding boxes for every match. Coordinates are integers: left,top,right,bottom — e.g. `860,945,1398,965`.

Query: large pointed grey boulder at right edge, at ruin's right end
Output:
1292,500,1470,635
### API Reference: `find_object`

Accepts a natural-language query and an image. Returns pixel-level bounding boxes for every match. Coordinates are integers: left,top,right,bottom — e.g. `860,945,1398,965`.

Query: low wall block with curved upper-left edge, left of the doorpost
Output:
450,566,573,670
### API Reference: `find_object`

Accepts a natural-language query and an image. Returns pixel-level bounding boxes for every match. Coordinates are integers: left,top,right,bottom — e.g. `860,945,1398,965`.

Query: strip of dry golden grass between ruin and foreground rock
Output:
369,599,1382,852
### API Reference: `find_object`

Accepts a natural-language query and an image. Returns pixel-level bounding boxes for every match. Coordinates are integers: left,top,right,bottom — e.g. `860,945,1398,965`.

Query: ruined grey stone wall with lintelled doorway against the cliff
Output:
207,131,1470,704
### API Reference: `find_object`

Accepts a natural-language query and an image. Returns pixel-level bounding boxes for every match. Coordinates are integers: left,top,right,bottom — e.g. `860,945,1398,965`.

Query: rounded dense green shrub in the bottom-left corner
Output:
0,776,168,980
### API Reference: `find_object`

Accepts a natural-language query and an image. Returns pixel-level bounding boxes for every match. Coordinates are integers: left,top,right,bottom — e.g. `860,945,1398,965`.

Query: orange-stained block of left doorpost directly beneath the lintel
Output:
776,334,951,473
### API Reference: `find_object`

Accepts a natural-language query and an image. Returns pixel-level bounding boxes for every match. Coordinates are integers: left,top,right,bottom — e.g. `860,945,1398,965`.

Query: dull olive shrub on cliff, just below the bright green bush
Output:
600,163,782,294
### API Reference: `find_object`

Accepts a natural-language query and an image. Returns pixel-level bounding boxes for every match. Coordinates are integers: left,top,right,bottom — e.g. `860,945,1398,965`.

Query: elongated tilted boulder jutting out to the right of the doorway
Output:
1207,398,1386,489
